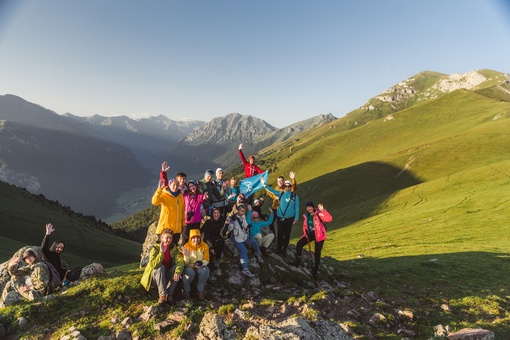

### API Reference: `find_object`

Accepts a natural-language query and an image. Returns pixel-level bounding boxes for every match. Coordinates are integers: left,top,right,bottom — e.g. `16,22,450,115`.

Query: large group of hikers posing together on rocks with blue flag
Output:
141,144,332,303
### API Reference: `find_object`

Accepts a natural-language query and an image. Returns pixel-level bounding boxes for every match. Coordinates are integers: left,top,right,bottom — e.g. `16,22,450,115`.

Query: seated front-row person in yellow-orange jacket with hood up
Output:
182,229,209,300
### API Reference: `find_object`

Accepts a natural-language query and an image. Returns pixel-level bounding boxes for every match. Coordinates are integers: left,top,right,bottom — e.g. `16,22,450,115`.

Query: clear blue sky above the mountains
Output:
0,0,510,127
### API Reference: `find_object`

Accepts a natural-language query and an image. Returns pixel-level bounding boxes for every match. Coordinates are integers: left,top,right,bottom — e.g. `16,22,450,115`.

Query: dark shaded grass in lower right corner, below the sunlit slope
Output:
327,252,510,339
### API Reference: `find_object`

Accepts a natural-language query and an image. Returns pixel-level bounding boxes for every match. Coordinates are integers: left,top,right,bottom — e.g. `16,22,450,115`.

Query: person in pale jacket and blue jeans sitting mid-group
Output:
228,204,264,277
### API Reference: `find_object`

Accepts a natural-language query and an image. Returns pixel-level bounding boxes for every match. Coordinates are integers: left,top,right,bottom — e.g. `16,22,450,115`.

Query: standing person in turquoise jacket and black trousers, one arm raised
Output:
260,178,299,257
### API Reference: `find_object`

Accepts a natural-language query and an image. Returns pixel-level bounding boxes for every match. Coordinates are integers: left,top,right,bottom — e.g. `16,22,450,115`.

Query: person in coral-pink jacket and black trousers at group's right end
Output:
293,201,333,279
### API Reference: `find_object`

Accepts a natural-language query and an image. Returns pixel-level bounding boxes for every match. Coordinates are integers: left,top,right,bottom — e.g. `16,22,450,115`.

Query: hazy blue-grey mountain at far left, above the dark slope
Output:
0,96,152,217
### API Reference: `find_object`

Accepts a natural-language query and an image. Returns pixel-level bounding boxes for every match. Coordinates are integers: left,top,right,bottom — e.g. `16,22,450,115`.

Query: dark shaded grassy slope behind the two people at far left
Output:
0,182,141,267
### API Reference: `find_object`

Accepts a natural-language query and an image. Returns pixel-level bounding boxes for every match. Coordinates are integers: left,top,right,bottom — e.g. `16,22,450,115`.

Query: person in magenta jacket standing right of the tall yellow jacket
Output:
181,180,209,244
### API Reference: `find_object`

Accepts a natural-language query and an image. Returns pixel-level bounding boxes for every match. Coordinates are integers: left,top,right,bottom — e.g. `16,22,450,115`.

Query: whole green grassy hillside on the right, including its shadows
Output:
258,91,510,337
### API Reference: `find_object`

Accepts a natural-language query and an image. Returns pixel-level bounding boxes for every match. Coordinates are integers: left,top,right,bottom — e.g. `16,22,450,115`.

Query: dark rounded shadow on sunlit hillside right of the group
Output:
290,162,423,230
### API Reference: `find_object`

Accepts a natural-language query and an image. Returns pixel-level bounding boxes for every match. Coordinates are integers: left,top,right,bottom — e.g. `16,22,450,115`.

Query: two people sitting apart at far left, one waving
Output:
2,223,79,301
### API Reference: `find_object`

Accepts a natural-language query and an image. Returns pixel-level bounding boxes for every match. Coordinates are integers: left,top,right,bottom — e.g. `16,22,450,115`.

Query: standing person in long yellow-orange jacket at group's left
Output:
152,171,186,240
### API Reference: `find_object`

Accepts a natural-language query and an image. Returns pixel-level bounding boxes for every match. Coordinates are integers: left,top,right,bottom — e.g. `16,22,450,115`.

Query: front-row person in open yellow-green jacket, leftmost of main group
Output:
140,229,184,303
